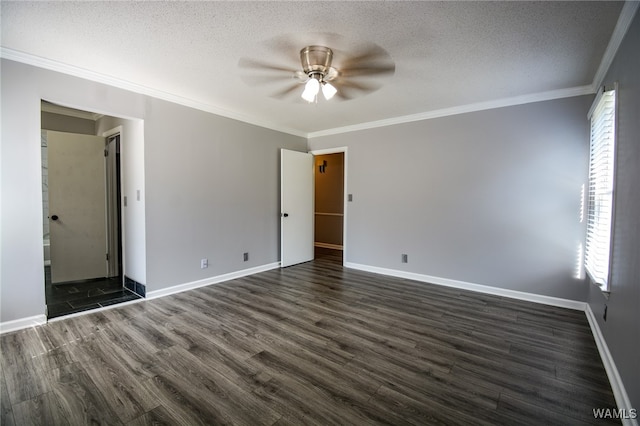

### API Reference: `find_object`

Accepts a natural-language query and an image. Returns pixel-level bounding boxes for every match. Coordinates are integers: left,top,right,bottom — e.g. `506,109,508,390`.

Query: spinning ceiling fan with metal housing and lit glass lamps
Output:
238,43,395,103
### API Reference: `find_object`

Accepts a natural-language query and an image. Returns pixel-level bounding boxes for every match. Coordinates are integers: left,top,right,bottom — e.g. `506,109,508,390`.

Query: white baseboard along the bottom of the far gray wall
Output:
344,262,586,311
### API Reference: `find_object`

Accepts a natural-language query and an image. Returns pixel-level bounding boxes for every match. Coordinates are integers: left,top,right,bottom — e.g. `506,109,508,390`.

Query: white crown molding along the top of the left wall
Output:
0,47,307,138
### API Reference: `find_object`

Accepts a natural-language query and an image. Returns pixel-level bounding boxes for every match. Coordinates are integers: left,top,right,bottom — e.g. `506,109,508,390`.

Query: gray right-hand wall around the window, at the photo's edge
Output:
589,10,640,409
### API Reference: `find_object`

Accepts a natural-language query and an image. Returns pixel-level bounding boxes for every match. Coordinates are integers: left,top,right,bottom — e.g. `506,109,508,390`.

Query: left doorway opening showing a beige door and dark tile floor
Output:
41,103,140,319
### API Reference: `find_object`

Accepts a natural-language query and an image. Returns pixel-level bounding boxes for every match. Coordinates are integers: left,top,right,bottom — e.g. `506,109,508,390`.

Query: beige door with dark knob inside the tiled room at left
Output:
47,132,107,283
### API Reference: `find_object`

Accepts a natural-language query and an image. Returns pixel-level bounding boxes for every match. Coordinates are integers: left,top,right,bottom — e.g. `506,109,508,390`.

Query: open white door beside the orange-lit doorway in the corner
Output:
280,149,314,268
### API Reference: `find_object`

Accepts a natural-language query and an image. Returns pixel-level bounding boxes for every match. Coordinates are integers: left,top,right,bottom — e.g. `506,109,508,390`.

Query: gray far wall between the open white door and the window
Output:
309,96,592,301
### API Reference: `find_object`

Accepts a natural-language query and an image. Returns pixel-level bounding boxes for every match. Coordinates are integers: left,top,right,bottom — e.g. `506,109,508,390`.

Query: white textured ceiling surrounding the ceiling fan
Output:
1,0,635,136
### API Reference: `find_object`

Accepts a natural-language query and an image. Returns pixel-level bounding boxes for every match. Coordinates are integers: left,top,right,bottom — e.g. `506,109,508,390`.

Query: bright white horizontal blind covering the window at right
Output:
585,90,616,291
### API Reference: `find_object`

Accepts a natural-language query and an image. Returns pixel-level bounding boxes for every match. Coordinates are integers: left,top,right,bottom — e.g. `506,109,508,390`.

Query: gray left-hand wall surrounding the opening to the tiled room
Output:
0,59,306,322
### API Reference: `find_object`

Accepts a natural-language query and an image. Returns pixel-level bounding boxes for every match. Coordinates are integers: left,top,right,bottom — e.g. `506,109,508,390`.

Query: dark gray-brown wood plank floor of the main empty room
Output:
0,251,615,425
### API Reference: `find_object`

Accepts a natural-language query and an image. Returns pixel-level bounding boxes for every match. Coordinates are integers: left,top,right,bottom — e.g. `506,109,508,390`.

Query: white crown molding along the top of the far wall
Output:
307,85,595,139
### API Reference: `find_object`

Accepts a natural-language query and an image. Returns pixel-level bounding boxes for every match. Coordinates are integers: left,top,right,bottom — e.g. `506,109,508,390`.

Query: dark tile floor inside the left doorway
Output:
45,266,141,319
